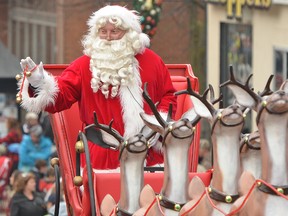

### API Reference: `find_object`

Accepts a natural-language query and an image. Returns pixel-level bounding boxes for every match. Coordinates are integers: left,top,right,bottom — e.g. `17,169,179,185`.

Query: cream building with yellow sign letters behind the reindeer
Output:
206,0,288,131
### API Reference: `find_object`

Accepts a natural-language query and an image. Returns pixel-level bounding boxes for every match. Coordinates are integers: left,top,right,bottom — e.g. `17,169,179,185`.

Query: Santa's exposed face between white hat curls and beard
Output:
98,22,126,41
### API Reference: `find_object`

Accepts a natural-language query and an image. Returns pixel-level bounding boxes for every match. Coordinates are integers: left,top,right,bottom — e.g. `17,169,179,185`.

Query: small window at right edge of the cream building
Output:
274,48,288,90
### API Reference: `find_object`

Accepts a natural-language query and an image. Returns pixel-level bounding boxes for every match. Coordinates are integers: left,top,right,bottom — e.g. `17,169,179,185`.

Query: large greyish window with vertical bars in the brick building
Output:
8,0,57,63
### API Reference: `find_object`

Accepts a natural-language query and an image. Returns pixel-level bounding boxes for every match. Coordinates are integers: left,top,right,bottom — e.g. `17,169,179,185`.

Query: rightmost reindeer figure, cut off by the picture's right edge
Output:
224,69,288,216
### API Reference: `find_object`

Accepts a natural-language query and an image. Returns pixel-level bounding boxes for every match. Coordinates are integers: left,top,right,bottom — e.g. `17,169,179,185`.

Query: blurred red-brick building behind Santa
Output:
0,0,206,135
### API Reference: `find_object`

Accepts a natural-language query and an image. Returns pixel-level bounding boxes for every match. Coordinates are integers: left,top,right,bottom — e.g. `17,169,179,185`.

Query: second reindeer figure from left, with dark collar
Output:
135,79,219,216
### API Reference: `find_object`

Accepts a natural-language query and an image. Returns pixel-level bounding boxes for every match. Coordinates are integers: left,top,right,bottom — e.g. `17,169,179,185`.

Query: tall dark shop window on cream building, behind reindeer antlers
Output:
220,23,252,132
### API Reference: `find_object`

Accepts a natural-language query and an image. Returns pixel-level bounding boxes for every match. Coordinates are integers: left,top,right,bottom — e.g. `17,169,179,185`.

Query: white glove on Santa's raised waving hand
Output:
20,57,44,88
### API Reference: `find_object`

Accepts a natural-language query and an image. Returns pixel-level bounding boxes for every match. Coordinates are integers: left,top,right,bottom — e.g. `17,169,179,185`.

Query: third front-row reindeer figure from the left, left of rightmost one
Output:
180,76,245,216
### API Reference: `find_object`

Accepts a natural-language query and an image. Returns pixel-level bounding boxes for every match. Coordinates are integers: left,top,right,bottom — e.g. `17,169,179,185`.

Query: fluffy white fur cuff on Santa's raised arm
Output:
18,71,59,113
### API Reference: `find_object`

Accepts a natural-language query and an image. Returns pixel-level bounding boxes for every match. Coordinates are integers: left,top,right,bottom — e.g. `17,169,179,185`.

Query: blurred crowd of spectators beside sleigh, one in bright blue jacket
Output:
0,112,67,216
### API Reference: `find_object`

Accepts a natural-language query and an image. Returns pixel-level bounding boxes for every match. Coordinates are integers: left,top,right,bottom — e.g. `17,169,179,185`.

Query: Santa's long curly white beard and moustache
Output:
90,35,139,98
